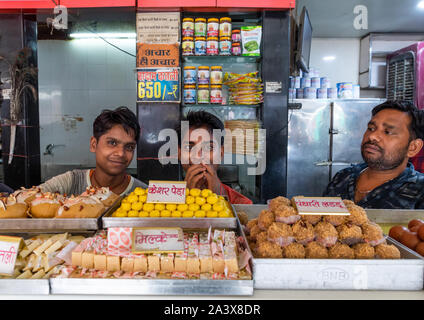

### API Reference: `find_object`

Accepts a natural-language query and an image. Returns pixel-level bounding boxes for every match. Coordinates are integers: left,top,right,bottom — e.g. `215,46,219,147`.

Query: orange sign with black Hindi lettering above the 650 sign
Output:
137,43,180,68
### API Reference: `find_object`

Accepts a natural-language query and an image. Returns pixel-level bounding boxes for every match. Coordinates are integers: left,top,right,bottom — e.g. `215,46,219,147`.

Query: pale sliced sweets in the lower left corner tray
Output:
0,233,85,279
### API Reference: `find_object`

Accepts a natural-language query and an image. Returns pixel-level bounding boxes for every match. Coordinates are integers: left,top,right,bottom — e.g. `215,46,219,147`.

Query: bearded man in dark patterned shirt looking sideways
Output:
324,101,424,209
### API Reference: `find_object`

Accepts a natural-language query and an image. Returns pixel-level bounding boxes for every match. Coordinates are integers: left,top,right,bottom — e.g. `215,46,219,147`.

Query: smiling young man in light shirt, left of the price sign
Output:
40,107,147,195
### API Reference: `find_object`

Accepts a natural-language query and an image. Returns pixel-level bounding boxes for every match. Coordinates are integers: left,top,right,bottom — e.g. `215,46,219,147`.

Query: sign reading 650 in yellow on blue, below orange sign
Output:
137,68,180,103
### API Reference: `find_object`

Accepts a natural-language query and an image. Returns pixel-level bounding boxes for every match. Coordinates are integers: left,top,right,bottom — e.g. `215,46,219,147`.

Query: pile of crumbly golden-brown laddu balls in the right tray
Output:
239,197,400,259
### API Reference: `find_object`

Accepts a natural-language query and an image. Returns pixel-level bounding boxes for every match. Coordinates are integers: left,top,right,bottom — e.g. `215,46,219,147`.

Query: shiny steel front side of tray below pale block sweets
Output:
50,278,253,296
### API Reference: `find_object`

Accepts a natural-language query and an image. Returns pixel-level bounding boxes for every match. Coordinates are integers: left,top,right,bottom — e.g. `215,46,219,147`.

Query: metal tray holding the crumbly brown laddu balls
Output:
234,205,424,290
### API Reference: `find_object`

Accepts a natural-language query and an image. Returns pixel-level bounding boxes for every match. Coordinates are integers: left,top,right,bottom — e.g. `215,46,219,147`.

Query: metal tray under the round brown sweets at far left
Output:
0,198,121,233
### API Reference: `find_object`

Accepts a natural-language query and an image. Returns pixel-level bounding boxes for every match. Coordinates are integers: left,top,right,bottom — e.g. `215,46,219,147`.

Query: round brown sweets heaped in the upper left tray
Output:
0,187,119,219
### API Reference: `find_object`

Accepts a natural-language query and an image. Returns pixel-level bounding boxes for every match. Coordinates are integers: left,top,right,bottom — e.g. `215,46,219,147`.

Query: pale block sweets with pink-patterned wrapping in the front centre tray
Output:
55,228,251,280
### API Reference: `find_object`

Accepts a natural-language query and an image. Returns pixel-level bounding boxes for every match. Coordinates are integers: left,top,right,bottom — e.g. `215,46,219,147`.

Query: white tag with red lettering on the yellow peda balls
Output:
146,180,187,203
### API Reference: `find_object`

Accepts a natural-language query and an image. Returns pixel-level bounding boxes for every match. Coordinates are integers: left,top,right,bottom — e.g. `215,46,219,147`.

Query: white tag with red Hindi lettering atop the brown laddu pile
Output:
293,197,350,216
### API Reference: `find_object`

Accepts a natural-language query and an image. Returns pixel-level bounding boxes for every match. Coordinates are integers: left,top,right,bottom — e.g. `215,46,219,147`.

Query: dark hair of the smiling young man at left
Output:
93,107,140,141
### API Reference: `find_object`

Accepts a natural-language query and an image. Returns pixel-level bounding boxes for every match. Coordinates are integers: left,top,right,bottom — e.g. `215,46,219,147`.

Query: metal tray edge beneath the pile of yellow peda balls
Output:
102,201,237,229
